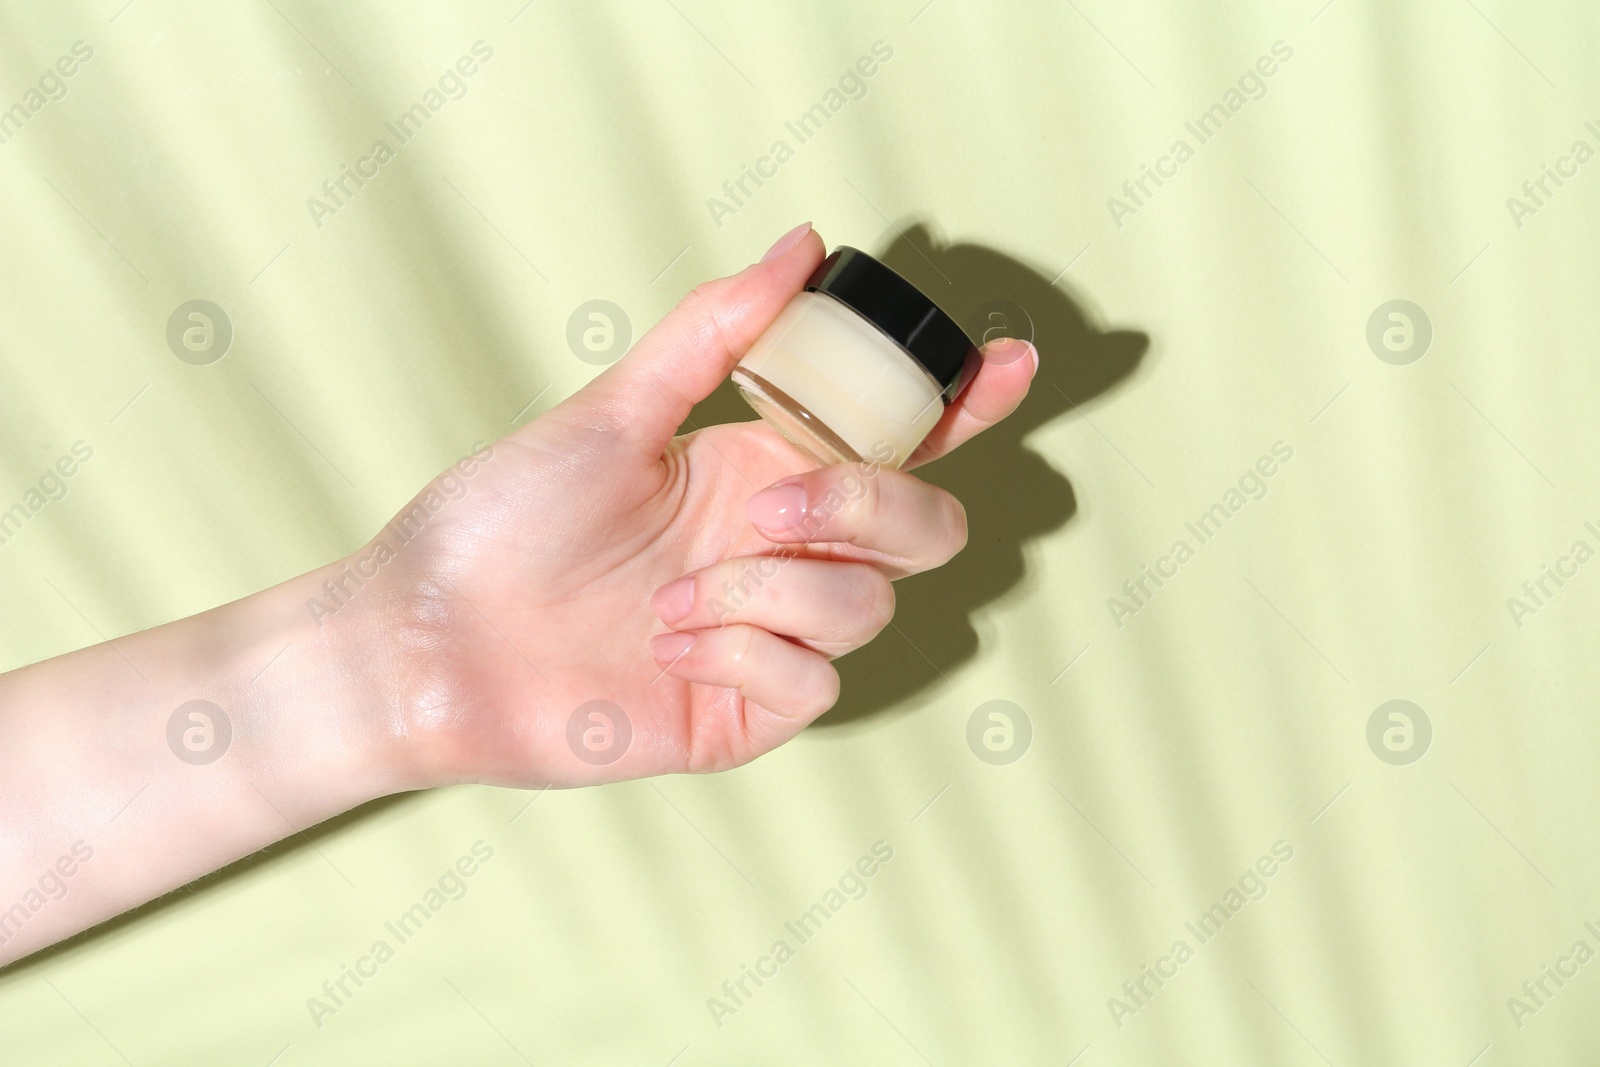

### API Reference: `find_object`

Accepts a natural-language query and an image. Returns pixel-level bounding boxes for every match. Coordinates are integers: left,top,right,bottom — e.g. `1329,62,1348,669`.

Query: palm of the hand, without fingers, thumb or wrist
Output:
382,412,813,785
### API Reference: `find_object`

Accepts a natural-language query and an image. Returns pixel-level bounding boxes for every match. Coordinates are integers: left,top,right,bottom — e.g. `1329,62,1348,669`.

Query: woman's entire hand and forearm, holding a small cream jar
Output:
0,220,1035,966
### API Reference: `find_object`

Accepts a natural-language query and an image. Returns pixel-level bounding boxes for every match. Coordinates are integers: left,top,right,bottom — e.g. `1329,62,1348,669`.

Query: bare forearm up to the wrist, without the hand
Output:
0,565,411,965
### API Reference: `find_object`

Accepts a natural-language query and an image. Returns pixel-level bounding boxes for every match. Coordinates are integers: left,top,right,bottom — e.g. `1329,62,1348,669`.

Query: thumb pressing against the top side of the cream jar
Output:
552,222,822,458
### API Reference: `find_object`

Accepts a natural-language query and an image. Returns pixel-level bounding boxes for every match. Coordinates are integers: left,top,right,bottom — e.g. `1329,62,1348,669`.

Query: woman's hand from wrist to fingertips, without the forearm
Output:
361,226,1037,785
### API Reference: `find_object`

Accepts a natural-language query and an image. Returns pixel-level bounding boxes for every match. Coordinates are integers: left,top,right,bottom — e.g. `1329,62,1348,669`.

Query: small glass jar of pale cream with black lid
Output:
733,246,978,467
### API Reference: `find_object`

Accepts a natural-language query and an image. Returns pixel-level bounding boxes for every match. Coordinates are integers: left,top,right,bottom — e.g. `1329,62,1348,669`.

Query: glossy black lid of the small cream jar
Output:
805,245,976,400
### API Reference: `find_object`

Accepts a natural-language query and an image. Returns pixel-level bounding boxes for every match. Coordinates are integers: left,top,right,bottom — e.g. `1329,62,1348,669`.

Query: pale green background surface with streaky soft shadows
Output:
0,0,1600,1067
